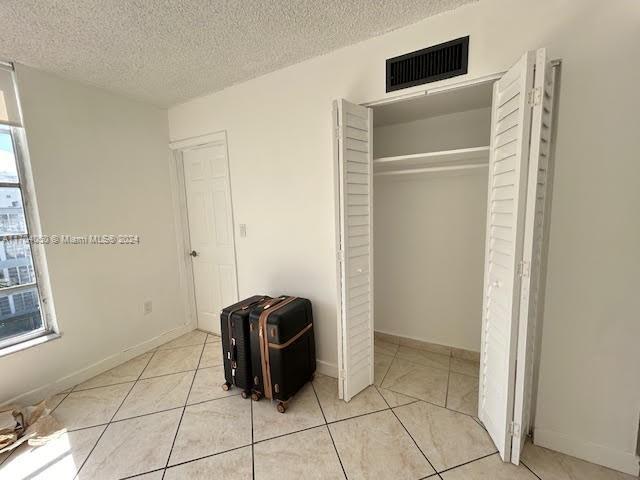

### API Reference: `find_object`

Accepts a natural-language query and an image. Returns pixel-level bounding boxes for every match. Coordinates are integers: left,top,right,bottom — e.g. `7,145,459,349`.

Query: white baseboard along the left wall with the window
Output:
6,324,195,405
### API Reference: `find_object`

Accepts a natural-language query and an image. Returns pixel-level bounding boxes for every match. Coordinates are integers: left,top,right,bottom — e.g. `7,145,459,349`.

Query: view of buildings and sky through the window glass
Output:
0,125,43,341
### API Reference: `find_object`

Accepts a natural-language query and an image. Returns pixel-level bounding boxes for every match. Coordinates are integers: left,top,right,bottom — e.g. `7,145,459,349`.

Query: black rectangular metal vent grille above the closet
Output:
387,36,469,92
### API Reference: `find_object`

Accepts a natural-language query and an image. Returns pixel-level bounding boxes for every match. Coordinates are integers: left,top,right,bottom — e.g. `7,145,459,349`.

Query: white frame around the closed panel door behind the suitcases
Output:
169,130,239,334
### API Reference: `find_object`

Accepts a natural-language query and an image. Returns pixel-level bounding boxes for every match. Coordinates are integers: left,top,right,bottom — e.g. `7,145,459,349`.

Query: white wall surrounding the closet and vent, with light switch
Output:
169,0,640,472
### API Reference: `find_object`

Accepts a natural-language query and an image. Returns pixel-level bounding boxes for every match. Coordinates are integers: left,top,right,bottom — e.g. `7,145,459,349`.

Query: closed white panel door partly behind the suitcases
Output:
182,142,238,333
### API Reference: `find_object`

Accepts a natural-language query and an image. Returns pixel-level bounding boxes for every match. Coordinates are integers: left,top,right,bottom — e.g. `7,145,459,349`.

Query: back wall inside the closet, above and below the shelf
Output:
373,108,491,352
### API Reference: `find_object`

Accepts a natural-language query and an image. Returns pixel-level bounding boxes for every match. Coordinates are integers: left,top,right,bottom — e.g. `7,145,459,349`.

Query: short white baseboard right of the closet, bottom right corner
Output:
533,427,640,476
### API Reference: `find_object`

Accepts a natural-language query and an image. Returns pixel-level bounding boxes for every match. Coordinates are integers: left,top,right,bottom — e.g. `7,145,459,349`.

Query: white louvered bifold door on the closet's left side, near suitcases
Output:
334,100,373,402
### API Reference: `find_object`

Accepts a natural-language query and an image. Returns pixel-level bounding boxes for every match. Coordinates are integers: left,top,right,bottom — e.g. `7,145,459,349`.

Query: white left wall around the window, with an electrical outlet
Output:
0,65,185,404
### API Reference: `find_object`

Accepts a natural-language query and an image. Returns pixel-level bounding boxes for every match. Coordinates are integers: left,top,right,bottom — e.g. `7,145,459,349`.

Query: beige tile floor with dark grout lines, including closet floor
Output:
0,331,634,480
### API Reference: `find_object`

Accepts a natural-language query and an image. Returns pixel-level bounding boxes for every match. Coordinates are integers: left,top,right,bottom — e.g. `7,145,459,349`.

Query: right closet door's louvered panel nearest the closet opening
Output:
478,52,535,461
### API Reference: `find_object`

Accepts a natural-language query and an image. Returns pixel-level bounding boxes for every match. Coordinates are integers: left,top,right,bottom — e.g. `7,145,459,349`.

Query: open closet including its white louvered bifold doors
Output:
333,48,560,465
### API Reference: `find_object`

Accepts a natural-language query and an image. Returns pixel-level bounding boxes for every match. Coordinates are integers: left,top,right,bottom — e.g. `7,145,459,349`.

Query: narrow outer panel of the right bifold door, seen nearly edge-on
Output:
511,48,554,465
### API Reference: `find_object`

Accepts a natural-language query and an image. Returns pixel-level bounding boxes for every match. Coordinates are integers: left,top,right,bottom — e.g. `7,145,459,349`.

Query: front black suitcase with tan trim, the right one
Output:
249,296,316,413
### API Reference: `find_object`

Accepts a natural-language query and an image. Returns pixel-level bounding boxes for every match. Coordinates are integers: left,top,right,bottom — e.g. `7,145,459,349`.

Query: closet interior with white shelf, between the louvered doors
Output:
372,82,493,416
